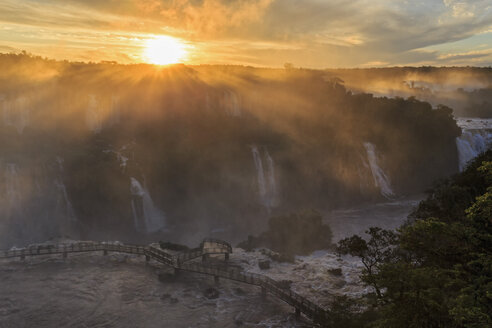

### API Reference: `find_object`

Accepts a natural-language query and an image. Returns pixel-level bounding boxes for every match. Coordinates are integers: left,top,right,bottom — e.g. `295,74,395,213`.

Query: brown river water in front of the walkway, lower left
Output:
0,253,302,328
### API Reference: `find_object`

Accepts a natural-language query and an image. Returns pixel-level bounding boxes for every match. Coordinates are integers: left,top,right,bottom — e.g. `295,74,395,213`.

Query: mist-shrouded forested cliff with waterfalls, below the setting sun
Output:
0,54,461,244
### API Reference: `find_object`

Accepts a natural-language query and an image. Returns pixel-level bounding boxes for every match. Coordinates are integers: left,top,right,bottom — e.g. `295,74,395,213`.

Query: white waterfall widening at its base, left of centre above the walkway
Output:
130,178,165,233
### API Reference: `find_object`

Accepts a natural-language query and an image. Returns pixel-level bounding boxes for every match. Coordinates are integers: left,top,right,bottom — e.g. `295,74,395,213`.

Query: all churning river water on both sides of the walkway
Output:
0,199,418,328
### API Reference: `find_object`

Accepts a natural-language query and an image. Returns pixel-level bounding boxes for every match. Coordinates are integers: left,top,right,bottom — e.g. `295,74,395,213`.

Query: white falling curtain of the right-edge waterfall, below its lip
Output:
456,130,492,171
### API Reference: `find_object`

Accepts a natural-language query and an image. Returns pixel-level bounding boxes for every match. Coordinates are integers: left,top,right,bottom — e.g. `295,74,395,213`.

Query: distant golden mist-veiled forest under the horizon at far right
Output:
326,66,492,118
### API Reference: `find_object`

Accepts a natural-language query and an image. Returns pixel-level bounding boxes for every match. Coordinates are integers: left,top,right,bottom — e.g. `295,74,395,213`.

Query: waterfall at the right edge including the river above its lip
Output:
456,118,492,171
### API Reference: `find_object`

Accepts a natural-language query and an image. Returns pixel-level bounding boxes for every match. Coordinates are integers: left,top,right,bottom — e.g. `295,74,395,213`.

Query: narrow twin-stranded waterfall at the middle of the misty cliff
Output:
251,145,278,209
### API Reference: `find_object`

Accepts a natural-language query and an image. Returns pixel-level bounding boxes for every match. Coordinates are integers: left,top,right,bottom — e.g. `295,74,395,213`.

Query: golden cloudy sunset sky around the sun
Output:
0,0,492,68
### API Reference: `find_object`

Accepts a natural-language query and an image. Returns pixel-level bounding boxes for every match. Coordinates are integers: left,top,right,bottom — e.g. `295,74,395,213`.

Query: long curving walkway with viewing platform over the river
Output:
0,239,328,323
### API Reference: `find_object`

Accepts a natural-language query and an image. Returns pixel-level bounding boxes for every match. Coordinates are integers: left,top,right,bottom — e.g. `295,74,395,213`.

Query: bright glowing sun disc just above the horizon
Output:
144,35,188,65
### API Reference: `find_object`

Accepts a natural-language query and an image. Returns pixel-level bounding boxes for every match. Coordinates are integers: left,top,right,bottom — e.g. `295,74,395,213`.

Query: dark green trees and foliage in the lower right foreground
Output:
338,151,492,328
